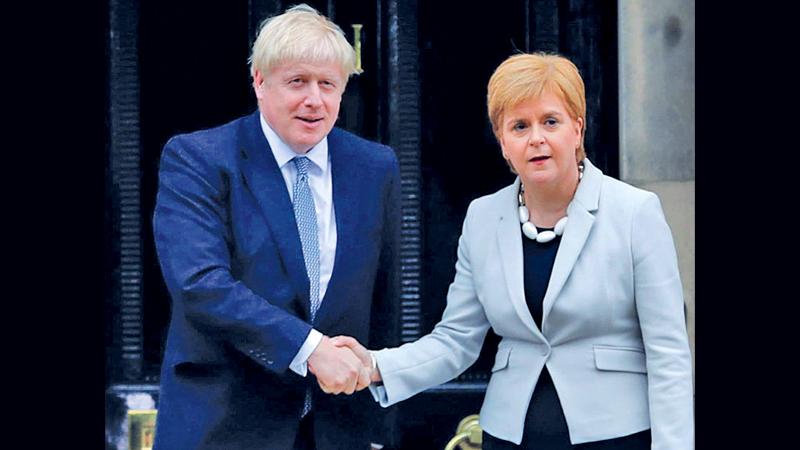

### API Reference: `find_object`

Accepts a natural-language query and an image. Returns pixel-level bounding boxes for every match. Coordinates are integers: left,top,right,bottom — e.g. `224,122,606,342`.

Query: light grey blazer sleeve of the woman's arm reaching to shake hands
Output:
371,203,489,407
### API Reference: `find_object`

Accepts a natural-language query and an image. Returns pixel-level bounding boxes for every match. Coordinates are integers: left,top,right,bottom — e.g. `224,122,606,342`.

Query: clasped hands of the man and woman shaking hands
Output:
308,336,381,395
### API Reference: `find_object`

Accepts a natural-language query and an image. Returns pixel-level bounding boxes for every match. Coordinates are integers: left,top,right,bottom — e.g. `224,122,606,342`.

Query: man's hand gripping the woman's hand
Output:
308,336,370,395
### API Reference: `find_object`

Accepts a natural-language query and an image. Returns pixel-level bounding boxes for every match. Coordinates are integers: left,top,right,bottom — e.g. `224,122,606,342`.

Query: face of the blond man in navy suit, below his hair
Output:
253,62,347,154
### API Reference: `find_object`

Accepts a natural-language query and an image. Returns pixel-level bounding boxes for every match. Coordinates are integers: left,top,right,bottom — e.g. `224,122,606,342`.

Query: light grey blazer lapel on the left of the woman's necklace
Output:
497,178,544,340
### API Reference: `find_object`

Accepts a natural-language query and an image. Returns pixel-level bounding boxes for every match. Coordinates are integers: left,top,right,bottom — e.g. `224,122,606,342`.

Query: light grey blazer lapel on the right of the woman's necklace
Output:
542,159,603,328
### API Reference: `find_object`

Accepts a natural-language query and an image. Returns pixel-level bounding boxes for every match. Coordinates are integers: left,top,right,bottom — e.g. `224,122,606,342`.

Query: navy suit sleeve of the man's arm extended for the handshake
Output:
153,136,311,372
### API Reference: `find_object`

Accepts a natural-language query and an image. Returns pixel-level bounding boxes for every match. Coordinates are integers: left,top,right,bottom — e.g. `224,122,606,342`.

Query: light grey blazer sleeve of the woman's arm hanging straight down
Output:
631,193,694,450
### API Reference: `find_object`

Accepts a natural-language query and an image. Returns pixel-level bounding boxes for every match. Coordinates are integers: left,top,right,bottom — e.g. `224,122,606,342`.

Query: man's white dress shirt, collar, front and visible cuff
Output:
259,115,336,376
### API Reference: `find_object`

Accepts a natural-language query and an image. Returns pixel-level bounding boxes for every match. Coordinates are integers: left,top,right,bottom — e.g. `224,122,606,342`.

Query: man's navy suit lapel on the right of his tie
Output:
314,128,360,328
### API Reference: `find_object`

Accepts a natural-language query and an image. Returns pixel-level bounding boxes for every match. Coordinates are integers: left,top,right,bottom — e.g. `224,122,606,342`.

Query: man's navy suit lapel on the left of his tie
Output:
239,111,310,320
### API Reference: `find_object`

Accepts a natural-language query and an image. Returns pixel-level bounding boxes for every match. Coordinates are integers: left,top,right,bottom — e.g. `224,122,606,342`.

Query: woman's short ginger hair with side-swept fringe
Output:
486,53,586,160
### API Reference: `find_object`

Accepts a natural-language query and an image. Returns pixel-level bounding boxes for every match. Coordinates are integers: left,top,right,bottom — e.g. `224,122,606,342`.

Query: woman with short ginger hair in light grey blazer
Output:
335,54,694,450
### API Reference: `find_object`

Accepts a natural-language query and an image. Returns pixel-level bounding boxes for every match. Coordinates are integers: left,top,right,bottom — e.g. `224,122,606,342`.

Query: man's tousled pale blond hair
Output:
248,4,358,80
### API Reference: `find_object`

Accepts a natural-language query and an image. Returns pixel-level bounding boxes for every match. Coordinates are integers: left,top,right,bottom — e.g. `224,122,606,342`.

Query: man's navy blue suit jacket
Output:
153,111,400,450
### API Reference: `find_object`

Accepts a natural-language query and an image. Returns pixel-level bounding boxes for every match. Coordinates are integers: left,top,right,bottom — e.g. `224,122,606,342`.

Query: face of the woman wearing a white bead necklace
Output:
500,92,583,188
